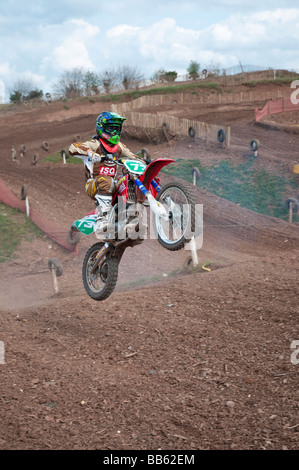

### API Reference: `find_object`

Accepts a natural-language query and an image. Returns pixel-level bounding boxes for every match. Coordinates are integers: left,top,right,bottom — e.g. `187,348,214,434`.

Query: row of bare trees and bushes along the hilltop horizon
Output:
9,60,220,103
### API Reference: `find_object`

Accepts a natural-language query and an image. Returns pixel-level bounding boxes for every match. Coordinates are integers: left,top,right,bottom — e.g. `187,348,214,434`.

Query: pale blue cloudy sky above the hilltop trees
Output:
0,0,299,99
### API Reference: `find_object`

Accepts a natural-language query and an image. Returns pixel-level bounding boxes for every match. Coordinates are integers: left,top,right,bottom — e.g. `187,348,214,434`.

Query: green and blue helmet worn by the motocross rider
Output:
96,112,126,146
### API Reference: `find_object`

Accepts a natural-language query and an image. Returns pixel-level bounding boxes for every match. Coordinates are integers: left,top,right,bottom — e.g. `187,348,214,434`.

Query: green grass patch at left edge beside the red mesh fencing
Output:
0,203,43,263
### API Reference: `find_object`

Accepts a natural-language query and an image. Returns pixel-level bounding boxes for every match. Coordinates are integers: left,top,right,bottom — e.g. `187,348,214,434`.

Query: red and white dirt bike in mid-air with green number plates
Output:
68,158,195,300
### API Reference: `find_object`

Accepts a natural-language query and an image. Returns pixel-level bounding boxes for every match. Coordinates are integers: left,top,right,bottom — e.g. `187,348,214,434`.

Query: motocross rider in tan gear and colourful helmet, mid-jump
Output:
69,112,143,225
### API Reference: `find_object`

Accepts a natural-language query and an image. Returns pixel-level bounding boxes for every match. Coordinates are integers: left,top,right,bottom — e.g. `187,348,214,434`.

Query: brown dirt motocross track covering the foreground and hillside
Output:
0,85,299,450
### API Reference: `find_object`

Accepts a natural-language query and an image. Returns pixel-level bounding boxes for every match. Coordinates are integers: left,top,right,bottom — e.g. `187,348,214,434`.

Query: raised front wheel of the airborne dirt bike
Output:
154,182,195,251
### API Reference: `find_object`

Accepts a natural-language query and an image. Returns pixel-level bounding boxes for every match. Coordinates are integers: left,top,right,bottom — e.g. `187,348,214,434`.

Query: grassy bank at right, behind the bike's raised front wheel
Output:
162,159,299,221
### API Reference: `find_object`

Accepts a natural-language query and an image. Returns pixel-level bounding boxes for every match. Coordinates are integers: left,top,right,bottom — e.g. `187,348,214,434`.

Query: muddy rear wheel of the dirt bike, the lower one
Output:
82,242,118,300
